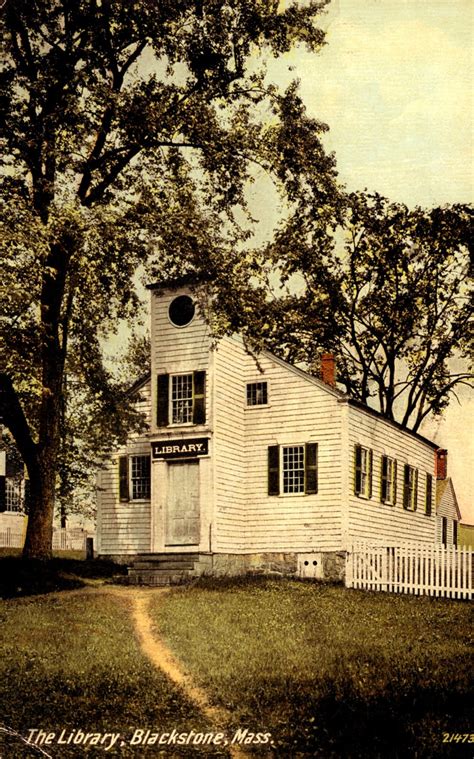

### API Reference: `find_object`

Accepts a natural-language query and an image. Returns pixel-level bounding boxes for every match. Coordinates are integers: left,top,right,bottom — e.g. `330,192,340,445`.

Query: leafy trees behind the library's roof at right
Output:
265,193,473,430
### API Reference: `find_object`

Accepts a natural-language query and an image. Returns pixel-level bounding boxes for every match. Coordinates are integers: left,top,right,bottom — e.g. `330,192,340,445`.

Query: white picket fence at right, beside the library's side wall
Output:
345,542,473,599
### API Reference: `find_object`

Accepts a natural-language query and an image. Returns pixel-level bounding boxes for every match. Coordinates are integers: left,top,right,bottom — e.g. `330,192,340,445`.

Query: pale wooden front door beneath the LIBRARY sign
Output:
165,461,201,546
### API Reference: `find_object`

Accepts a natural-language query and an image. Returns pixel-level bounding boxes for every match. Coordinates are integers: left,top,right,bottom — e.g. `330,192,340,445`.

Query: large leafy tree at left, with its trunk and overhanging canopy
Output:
0,0,338,556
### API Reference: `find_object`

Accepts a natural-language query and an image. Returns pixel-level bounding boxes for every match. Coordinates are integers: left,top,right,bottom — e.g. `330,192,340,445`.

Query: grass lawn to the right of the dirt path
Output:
153,580,474,759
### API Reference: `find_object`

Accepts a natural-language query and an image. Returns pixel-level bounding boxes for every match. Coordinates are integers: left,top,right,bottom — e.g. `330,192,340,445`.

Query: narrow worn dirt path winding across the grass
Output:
128,590,251,759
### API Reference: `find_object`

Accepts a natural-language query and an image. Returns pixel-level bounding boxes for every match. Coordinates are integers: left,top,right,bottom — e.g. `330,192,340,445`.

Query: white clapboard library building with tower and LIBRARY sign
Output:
97,281,459,582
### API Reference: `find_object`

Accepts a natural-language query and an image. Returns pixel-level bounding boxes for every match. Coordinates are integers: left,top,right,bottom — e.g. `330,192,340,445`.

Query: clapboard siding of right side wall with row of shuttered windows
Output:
346,406,436,543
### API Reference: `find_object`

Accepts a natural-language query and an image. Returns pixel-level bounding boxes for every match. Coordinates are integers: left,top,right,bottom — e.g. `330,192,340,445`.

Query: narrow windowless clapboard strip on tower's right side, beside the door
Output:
213,339,246,552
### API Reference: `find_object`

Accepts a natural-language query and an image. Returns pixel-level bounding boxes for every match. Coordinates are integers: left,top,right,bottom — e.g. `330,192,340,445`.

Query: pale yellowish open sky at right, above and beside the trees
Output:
270,0,474,524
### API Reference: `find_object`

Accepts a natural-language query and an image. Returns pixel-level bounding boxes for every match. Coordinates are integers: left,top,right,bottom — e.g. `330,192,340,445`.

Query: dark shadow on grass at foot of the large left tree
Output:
0,556,126,598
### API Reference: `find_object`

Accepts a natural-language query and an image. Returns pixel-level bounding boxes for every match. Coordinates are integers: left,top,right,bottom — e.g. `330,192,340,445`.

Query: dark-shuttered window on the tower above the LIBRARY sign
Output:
157,372,206,427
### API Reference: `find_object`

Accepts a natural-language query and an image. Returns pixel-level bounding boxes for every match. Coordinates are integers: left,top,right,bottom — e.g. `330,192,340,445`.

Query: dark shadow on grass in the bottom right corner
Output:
252,682,473,759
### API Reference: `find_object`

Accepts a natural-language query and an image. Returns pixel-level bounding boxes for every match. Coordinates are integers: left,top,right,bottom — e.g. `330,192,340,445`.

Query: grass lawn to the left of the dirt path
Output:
0,592,230,759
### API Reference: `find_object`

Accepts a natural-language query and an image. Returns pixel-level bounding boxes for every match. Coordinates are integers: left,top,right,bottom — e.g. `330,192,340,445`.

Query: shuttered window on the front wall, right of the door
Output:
268,443,318,495
